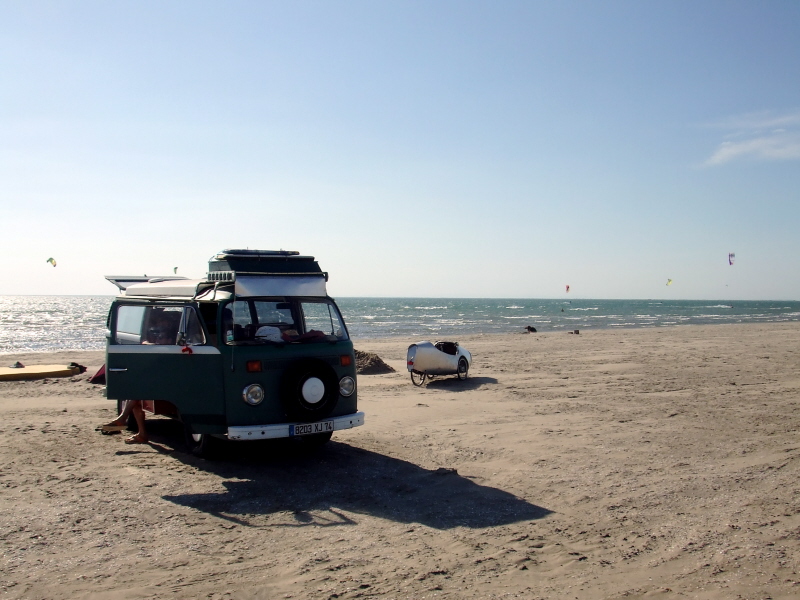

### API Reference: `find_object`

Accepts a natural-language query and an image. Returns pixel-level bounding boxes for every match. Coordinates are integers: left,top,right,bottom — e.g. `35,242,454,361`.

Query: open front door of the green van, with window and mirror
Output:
106,302,227,433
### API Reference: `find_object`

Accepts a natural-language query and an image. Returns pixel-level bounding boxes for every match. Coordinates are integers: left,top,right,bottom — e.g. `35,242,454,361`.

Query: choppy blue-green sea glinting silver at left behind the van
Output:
0,296,800,354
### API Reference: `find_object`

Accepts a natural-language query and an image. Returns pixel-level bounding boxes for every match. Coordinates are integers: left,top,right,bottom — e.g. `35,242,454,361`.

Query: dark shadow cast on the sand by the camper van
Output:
164,428,551,529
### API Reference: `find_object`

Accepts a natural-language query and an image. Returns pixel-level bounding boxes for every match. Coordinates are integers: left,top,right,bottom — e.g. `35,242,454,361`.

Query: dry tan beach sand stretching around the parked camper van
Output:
0,323,800,600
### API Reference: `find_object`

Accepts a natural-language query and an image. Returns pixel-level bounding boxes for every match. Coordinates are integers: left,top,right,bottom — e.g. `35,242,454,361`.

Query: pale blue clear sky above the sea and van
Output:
0,0,800,300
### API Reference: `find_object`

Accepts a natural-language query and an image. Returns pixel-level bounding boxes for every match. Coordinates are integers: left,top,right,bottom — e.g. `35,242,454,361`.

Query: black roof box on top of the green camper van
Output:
208,249,328,281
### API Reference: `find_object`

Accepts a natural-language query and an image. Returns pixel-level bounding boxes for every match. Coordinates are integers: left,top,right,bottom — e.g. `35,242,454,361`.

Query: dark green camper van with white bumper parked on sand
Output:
106,250,364,455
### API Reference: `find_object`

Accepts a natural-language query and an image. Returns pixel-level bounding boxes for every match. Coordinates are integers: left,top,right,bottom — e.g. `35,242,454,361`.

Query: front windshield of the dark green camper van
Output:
222,298,348,345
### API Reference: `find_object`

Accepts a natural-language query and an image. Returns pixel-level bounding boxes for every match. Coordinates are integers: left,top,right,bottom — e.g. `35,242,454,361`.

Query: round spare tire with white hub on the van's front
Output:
281,358,339,423
